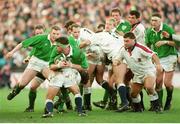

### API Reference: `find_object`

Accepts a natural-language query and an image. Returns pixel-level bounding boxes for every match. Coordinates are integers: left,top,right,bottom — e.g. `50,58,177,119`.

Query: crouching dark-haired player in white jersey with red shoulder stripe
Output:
113,32,162,112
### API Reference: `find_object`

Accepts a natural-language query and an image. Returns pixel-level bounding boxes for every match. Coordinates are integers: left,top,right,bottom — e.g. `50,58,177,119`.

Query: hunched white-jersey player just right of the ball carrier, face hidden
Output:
78,22,106,111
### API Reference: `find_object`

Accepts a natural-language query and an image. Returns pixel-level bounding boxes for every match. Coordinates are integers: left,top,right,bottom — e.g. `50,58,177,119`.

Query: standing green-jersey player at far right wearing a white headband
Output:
146,13,177,110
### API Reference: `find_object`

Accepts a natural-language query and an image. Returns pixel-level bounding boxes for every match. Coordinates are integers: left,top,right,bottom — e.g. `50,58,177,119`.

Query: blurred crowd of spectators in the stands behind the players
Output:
0,0,180,87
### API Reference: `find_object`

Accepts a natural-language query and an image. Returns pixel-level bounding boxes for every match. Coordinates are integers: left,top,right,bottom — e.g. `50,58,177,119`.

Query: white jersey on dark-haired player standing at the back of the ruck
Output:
131,23,145,45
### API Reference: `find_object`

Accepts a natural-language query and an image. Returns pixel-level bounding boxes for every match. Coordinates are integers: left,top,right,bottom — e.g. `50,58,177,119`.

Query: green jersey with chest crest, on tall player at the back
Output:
116,20,131,33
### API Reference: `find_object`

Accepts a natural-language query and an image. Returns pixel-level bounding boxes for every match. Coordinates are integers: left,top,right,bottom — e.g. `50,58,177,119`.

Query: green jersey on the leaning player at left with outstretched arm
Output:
22,35,53,61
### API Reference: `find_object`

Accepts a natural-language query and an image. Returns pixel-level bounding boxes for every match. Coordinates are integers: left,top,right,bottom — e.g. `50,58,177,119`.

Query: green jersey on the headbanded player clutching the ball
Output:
49,46,88,69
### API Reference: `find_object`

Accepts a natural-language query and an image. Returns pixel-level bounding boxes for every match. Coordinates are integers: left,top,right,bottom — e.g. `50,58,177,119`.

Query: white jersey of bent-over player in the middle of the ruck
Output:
91,32,124,60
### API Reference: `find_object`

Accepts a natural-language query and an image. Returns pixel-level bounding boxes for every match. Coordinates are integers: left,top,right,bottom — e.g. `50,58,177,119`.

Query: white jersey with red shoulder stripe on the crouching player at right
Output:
115,43,155,75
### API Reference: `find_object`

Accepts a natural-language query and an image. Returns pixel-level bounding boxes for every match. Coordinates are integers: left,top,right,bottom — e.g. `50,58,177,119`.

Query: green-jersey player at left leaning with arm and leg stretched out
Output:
6,26,60,100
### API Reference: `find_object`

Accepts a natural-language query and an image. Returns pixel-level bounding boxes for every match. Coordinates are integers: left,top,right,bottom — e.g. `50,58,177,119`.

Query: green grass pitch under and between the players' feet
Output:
0,89,180,123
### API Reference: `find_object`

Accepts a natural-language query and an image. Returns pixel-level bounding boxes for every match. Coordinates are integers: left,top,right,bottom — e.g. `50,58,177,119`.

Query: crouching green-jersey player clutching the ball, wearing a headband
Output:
42,37,88,118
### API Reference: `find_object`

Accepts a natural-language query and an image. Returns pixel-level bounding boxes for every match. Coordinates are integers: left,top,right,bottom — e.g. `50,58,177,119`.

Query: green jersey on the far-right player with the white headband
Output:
145,24,177,58
